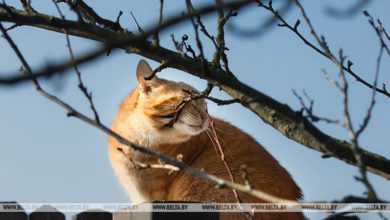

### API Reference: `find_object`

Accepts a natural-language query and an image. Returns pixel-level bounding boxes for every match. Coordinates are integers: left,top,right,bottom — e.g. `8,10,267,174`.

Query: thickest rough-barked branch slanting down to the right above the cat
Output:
0,1,390,178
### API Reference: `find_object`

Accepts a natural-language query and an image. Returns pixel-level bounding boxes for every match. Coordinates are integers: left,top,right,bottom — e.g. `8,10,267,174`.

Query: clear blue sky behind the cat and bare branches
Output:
0,0,390,218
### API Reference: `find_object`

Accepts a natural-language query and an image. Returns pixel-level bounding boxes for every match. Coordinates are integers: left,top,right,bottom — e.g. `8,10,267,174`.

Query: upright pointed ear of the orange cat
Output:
137,59,159,92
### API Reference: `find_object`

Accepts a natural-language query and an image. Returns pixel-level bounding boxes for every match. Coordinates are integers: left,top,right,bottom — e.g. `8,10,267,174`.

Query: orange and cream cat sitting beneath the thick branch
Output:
108,60,303,219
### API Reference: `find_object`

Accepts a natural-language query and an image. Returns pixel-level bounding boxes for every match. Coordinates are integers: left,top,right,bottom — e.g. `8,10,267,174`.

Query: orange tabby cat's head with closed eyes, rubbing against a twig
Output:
129,60,209,145
